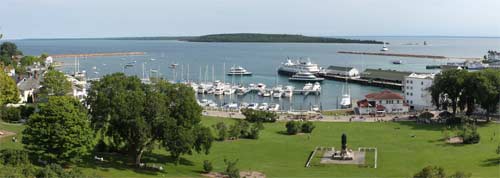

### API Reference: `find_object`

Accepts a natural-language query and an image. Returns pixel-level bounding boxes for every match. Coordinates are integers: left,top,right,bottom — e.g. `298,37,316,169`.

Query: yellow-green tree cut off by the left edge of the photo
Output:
0,69,19,106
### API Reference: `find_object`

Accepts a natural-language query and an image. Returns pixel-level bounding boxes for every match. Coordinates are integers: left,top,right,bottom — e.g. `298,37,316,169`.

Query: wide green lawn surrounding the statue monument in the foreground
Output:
0,118,500,177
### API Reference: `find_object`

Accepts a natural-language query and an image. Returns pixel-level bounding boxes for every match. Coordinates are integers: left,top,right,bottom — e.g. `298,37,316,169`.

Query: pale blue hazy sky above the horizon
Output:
0,0,500,39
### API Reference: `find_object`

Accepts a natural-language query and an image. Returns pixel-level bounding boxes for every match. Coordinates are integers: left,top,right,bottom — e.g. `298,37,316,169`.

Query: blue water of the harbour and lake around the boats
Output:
4,37,500,109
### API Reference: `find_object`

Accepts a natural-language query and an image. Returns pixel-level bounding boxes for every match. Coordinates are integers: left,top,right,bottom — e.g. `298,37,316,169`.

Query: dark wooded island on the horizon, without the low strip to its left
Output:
184,33,383,44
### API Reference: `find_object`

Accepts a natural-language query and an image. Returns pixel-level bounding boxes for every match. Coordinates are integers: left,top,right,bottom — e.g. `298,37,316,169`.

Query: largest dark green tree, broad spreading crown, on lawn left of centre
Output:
88,73,213,164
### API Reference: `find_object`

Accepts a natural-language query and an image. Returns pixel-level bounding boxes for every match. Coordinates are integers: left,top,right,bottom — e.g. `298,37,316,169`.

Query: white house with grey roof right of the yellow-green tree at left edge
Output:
17,77,41,103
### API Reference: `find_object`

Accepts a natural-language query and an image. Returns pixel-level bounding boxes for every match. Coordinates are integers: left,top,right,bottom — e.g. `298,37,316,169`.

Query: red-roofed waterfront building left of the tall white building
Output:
356,90,409,114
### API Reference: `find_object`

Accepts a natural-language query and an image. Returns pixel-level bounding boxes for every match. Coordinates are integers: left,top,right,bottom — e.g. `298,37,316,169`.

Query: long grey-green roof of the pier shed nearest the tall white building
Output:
361,69,412,82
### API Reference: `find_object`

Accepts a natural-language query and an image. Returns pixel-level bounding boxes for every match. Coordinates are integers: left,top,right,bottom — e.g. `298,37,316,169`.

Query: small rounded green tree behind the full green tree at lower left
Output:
41,70,71,96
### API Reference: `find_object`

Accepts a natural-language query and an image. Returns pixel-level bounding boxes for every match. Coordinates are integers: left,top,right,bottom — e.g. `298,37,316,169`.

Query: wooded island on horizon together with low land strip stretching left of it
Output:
30,33,383,44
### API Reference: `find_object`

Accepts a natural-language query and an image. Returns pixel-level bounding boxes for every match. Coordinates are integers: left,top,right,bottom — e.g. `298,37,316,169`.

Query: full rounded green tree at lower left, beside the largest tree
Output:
22,96,94,164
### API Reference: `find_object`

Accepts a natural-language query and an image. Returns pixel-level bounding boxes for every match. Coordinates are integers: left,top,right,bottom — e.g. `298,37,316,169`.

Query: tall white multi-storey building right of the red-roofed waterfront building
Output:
403,73,434,110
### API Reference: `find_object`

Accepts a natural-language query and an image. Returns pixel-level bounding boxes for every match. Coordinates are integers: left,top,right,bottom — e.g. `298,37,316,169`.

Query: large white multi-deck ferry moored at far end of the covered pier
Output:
278,59,321,76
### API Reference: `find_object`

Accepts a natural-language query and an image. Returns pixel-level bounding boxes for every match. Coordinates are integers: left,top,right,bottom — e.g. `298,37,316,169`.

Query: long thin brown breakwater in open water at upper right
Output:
337,51,481,60
